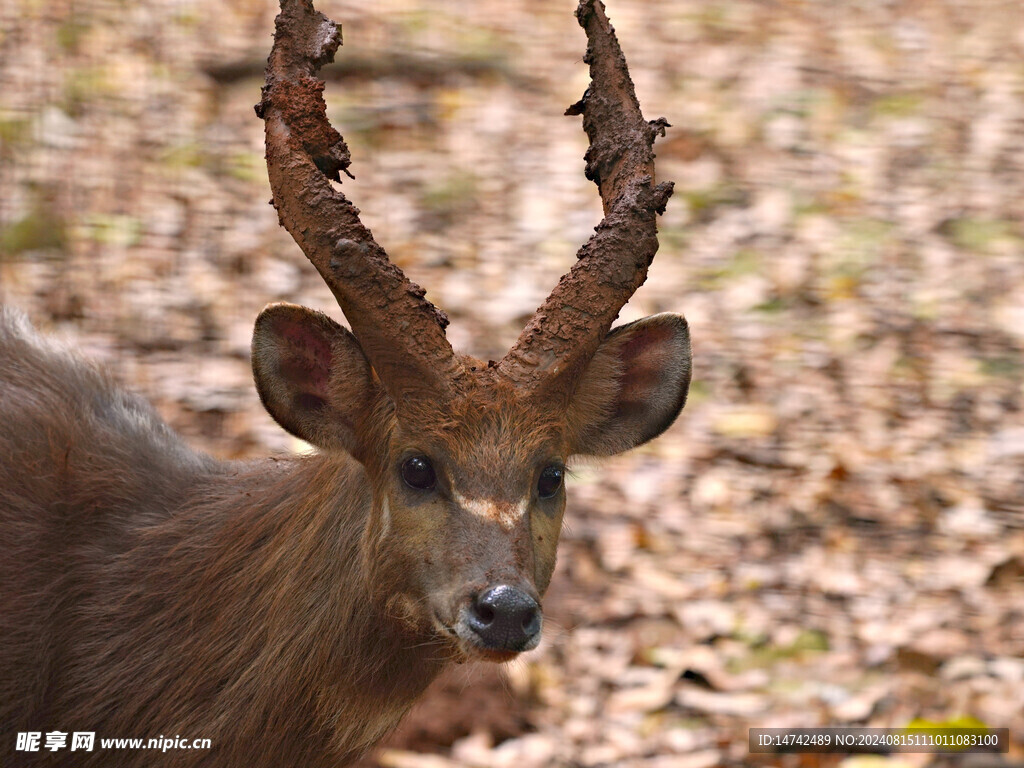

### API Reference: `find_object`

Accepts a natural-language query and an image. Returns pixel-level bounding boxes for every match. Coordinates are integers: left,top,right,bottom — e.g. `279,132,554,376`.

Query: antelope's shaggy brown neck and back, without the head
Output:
0,310,444,768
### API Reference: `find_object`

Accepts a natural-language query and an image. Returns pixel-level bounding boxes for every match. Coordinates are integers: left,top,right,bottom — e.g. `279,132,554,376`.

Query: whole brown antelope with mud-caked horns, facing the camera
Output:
0,0,690,768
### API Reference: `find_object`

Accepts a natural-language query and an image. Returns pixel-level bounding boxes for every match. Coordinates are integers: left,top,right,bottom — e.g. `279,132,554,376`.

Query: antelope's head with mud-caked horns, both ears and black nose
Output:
253,0,690,660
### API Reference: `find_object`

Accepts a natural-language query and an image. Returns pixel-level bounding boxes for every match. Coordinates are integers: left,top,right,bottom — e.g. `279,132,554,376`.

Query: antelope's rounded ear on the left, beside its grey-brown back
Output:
252,304,378,457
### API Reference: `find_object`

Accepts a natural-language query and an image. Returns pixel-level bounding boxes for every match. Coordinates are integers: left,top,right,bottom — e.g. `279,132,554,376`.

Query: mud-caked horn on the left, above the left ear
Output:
256,0,462,408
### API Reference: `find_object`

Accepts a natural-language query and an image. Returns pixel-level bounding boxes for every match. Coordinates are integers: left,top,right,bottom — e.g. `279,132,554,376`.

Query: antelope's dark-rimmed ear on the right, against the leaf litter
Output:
567,313,690,456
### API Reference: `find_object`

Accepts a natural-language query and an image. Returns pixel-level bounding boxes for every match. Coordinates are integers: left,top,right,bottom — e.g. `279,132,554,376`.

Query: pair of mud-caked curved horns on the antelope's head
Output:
256,0,673,408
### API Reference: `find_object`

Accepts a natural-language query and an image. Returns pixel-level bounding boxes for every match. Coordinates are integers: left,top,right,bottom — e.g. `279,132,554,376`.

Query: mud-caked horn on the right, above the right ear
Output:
499,0,673,402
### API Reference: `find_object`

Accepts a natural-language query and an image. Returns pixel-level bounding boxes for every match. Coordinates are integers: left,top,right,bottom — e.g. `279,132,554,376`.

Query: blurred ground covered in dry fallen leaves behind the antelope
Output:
0,0,1024,768
